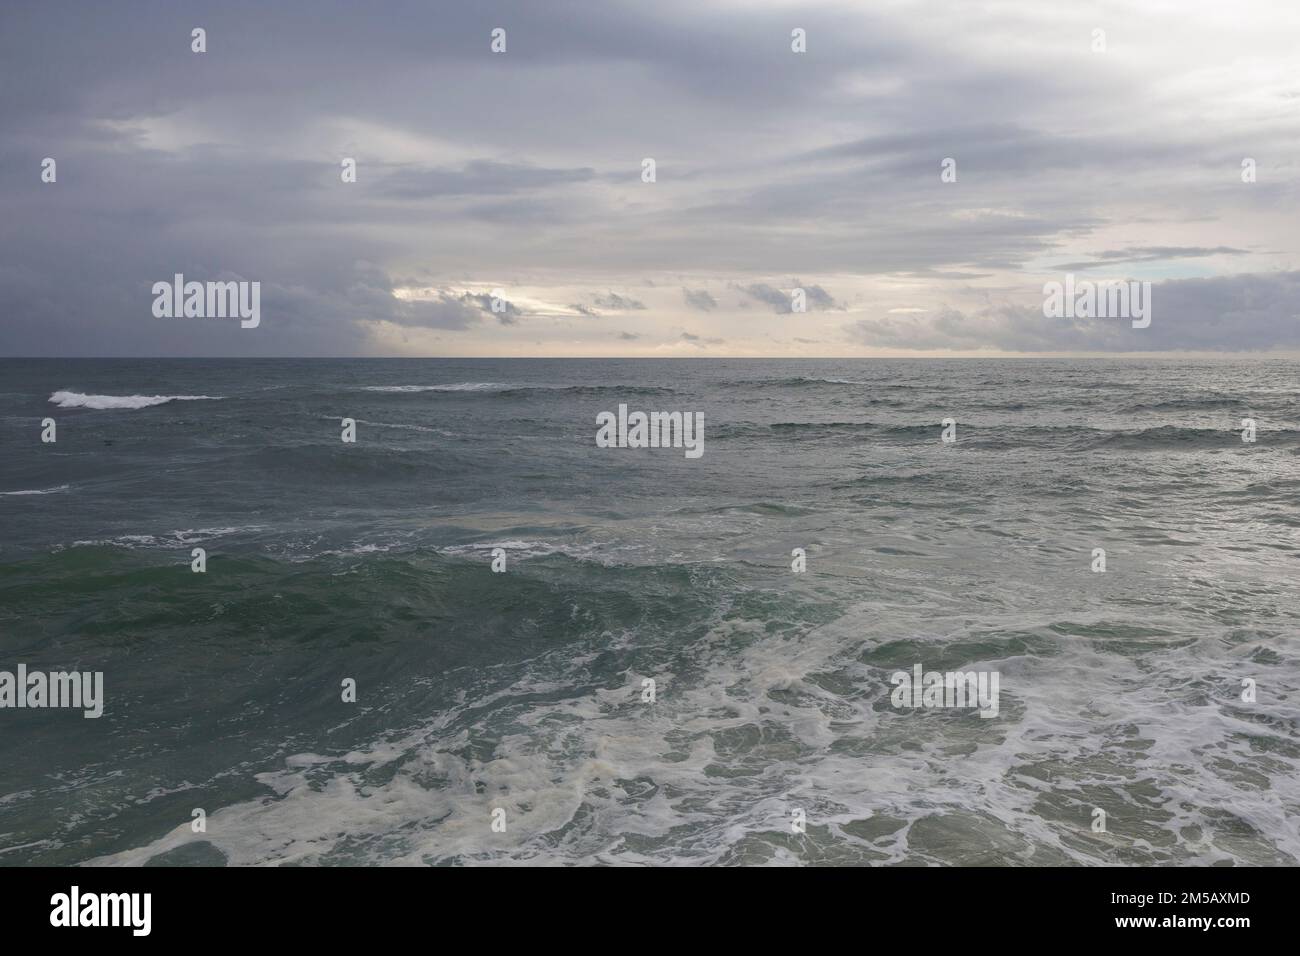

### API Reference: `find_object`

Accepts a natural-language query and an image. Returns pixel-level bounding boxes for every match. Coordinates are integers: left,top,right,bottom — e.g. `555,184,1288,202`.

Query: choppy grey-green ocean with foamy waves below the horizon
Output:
0,359,1300,866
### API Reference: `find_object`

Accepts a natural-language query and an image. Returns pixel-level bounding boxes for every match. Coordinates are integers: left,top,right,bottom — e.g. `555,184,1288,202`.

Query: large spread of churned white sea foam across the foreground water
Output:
86,602,1300,865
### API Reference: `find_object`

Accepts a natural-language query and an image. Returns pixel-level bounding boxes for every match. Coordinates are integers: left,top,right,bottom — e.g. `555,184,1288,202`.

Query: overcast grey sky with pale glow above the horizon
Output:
0,0,1300,356
